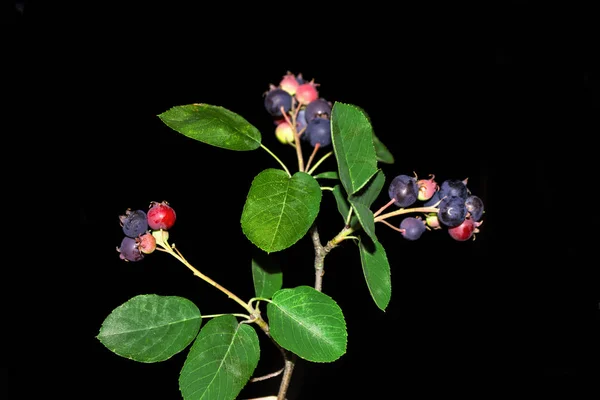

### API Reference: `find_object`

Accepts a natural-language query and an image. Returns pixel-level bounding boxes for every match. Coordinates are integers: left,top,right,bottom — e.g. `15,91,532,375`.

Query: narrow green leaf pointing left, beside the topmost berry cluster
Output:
158,104,261,151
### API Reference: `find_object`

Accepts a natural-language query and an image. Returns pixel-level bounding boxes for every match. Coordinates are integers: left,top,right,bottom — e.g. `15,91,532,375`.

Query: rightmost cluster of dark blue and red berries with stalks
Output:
378,174,484,242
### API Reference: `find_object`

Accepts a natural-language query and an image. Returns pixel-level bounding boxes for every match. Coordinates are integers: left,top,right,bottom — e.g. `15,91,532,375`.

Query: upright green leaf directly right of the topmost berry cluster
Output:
331,102,377,194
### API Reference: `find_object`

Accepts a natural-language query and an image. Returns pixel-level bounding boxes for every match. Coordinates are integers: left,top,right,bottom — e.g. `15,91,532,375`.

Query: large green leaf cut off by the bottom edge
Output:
179,315,260,400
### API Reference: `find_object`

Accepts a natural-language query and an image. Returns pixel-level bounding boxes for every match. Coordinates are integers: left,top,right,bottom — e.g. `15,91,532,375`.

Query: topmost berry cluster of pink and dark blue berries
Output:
264,72,332,147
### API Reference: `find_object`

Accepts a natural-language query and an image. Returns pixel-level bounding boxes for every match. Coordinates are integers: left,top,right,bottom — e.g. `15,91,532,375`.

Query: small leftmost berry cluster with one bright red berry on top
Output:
117,201,176,261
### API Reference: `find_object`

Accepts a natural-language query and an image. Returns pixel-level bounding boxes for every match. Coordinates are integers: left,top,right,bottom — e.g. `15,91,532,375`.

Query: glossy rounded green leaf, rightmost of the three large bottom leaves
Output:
267,286,348,362
